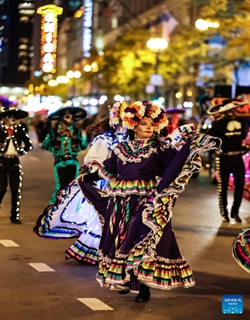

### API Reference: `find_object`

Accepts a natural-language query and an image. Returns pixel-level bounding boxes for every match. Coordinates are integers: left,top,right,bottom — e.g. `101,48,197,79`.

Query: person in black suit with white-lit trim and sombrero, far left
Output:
0,107,32,224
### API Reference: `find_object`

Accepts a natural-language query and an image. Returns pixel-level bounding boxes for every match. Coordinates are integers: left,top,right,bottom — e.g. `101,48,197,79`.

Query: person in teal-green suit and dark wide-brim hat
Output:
42,107,87,203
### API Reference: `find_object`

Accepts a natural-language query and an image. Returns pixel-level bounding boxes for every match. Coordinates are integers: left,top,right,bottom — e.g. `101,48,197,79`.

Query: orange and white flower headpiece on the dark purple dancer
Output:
121,101,168,133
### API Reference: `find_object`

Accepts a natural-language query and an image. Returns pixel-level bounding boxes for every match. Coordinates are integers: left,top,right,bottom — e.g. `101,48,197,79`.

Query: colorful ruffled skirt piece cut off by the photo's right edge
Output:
232,227,250,273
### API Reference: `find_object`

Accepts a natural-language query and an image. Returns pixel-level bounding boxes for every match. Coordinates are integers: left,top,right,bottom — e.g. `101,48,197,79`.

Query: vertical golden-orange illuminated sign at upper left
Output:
37,4,63,73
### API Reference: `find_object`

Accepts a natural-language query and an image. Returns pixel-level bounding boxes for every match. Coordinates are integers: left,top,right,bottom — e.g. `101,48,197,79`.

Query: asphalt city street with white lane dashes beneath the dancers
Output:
0,133,250,320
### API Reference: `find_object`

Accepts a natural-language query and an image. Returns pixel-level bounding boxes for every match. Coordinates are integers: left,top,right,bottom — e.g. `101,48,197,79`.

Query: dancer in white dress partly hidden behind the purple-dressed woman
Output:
34,102,126,264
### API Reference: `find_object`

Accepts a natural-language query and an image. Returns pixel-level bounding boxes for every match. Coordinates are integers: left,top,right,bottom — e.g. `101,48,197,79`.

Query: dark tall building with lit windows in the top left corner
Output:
0,0,35,86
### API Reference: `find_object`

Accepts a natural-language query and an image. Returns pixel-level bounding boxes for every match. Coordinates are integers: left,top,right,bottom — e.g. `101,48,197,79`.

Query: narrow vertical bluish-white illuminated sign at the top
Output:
83,0,93,57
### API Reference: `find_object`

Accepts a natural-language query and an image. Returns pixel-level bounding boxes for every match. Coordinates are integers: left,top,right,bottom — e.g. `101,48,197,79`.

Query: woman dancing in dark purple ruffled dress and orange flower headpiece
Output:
78,101,221,302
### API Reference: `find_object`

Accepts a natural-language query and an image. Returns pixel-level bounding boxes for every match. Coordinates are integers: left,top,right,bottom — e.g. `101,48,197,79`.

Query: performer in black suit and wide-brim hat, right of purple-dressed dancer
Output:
205,99,247,222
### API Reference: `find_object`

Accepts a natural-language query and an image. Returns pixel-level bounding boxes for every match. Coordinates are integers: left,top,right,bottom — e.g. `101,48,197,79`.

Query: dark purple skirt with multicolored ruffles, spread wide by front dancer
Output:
78,135,219,291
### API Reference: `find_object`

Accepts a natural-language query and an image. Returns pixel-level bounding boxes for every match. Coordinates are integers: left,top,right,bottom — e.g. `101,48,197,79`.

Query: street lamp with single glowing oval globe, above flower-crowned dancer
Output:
147,37,168,99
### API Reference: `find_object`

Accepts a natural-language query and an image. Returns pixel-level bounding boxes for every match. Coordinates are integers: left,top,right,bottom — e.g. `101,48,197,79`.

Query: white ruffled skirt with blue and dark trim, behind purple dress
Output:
34,180,106,264
